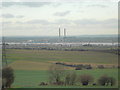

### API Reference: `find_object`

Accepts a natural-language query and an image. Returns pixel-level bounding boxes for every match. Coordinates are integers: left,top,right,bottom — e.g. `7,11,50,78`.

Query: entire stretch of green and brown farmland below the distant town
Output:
3,49,118,88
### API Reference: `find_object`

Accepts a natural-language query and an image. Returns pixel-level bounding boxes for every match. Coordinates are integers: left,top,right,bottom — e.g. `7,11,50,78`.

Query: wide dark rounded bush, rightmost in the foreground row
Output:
98,75,116,86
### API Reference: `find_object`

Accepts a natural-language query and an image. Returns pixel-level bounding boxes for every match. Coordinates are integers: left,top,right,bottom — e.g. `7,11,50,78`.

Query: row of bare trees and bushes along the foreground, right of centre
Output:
39,65,116,86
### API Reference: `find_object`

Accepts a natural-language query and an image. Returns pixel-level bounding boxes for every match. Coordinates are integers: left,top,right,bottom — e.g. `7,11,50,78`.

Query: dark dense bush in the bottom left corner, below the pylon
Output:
2,67,14,88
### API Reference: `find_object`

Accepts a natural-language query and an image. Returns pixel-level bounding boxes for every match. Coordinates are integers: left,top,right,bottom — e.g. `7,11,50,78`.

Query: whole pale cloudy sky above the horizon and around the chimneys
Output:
0,0,118,36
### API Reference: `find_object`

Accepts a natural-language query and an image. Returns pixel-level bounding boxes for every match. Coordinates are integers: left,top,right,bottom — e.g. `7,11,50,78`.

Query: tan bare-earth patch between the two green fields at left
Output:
9,61,73,70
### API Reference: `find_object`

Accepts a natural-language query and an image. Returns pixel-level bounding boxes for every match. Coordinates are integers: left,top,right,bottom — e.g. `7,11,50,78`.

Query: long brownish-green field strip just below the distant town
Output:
7,50,118,64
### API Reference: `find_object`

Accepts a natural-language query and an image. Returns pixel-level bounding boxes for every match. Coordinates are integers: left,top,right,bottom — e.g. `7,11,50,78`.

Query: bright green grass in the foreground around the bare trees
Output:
12,69,118,88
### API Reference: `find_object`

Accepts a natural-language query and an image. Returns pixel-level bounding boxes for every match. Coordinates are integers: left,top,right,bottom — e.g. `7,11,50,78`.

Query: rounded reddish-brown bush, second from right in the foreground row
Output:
78,75,94,85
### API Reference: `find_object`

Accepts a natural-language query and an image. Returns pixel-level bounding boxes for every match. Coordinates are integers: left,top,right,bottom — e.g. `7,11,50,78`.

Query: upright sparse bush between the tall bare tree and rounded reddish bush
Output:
65,72,77,85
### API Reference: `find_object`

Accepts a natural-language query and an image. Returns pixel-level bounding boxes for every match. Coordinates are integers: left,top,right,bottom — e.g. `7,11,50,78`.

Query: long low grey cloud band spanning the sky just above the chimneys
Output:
4,18,118,29
